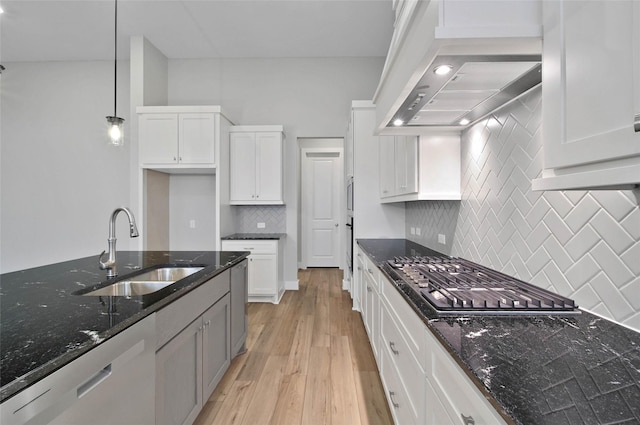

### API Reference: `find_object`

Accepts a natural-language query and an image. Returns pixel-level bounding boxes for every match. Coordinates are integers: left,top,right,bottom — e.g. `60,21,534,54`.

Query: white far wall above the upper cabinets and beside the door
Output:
168,54,384,281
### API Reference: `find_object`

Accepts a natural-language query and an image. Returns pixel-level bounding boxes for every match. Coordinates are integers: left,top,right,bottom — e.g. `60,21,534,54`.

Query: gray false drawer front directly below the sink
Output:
156,270,230,350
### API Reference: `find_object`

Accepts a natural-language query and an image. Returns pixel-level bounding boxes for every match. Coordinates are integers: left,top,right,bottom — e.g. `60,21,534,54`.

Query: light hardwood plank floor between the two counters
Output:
195,269,393,425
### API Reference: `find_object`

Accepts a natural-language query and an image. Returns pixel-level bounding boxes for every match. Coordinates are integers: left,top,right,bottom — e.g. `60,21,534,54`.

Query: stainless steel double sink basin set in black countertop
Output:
81,267,204,297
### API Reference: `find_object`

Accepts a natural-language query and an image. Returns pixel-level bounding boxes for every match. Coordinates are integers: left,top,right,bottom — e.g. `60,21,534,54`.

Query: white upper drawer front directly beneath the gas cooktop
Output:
380,276,427,370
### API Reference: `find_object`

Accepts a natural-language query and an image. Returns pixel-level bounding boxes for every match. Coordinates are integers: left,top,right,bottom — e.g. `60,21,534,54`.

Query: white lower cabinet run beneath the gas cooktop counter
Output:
356,250,506,425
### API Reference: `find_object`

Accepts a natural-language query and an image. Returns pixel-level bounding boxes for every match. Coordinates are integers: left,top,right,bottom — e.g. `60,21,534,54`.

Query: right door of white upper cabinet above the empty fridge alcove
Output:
178,113,215,164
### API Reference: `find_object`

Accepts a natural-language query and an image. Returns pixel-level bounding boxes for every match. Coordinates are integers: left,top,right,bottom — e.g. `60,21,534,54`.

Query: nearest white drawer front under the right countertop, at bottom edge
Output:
426,330,505,425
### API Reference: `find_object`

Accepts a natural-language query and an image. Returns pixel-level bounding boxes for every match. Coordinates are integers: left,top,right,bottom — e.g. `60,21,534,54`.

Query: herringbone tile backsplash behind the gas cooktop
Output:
406,88,640,331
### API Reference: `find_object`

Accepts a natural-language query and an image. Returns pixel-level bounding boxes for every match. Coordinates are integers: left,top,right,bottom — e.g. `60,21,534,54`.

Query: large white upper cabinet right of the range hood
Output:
533,0,640,190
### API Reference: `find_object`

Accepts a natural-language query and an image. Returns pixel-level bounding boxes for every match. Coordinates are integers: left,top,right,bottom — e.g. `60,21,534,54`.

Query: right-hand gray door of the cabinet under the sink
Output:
202,294,231,405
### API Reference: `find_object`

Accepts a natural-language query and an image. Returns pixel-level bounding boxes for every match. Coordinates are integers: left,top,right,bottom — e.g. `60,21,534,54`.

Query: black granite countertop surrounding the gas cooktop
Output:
358,239,640,425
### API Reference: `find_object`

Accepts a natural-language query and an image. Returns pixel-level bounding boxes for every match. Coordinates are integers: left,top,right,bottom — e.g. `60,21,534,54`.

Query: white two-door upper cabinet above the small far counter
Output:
230,125,284,205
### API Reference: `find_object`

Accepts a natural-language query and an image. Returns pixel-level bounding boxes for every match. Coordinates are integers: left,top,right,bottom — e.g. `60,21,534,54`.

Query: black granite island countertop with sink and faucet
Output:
0,251,249,401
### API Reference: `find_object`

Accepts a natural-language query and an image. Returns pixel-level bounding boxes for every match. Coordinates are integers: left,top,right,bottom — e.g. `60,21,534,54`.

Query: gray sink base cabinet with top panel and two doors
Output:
155,270,231,425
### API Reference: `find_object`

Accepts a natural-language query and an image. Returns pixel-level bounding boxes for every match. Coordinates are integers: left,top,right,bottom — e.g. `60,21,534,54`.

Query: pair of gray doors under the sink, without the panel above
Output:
156,294,231,425
